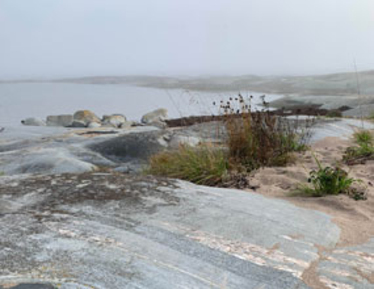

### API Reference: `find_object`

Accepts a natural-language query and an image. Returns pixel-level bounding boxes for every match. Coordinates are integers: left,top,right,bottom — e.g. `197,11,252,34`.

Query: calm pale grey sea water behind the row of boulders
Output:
0,83,281,127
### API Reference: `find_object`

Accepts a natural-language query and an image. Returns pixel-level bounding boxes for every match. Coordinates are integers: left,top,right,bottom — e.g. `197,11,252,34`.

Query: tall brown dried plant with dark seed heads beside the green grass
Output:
221,95,309,171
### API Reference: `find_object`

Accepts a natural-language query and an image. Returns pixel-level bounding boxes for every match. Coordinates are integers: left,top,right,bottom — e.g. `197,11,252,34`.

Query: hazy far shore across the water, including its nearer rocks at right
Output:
0,70,374,117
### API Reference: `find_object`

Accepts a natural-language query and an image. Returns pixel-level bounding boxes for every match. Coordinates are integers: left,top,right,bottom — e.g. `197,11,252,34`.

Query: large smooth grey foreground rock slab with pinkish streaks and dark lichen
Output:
0,173,339,289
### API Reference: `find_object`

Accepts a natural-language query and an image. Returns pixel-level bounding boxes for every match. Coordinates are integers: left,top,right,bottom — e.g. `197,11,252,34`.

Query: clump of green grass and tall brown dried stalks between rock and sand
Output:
147,95,308,186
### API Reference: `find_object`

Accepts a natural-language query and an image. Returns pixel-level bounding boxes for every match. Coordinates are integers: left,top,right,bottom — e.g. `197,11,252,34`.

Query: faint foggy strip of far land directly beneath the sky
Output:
0,70,374,96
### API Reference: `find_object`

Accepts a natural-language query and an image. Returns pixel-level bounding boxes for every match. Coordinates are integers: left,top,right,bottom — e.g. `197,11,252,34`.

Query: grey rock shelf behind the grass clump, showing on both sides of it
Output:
0,119,374,175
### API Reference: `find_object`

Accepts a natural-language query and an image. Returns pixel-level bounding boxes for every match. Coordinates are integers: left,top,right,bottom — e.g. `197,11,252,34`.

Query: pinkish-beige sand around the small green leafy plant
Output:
250,137,374,247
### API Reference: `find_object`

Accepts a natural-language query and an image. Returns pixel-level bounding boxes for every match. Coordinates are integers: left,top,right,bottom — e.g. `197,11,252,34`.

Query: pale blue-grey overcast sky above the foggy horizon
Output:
0,0,374,78
